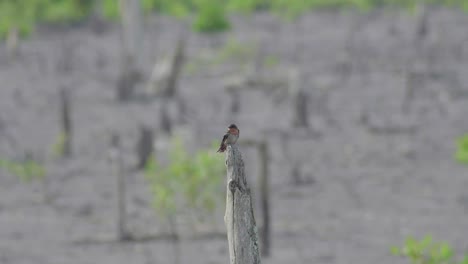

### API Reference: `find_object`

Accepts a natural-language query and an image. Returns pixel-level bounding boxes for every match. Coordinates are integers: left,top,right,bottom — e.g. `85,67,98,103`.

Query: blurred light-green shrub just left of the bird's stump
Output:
145,138,225,226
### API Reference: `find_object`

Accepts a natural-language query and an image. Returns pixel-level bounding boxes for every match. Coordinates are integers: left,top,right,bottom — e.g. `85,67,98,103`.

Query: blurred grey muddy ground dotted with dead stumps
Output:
0,6,468,264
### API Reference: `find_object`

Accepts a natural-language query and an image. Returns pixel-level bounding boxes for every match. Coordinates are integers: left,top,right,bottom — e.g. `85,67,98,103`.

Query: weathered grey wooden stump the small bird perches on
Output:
224,144,260,264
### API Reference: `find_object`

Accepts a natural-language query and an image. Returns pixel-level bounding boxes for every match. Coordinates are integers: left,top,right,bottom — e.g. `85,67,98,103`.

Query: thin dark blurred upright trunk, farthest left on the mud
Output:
59,86,72,157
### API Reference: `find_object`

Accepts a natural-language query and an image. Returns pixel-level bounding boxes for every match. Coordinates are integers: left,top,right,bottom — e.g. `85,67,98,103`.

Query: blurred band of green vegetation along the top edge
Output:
0,0,468,38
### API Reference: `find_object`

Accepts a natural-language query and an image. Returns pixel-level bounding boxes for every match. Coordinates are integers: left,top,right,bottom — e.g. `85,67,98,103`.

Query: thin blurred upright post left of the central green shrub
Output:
110,134,131,241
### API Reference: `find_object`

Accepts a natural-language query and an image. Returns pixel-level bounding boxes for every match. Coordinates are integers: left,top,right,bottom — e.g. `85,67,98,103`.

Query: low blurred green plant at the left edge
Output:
0,159,45,182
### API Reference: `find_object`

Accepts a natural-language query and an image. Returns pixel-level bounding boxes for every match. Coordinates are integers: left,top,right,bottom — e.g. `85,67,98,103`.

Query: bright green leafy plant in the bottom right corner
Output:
391,235,468,264
